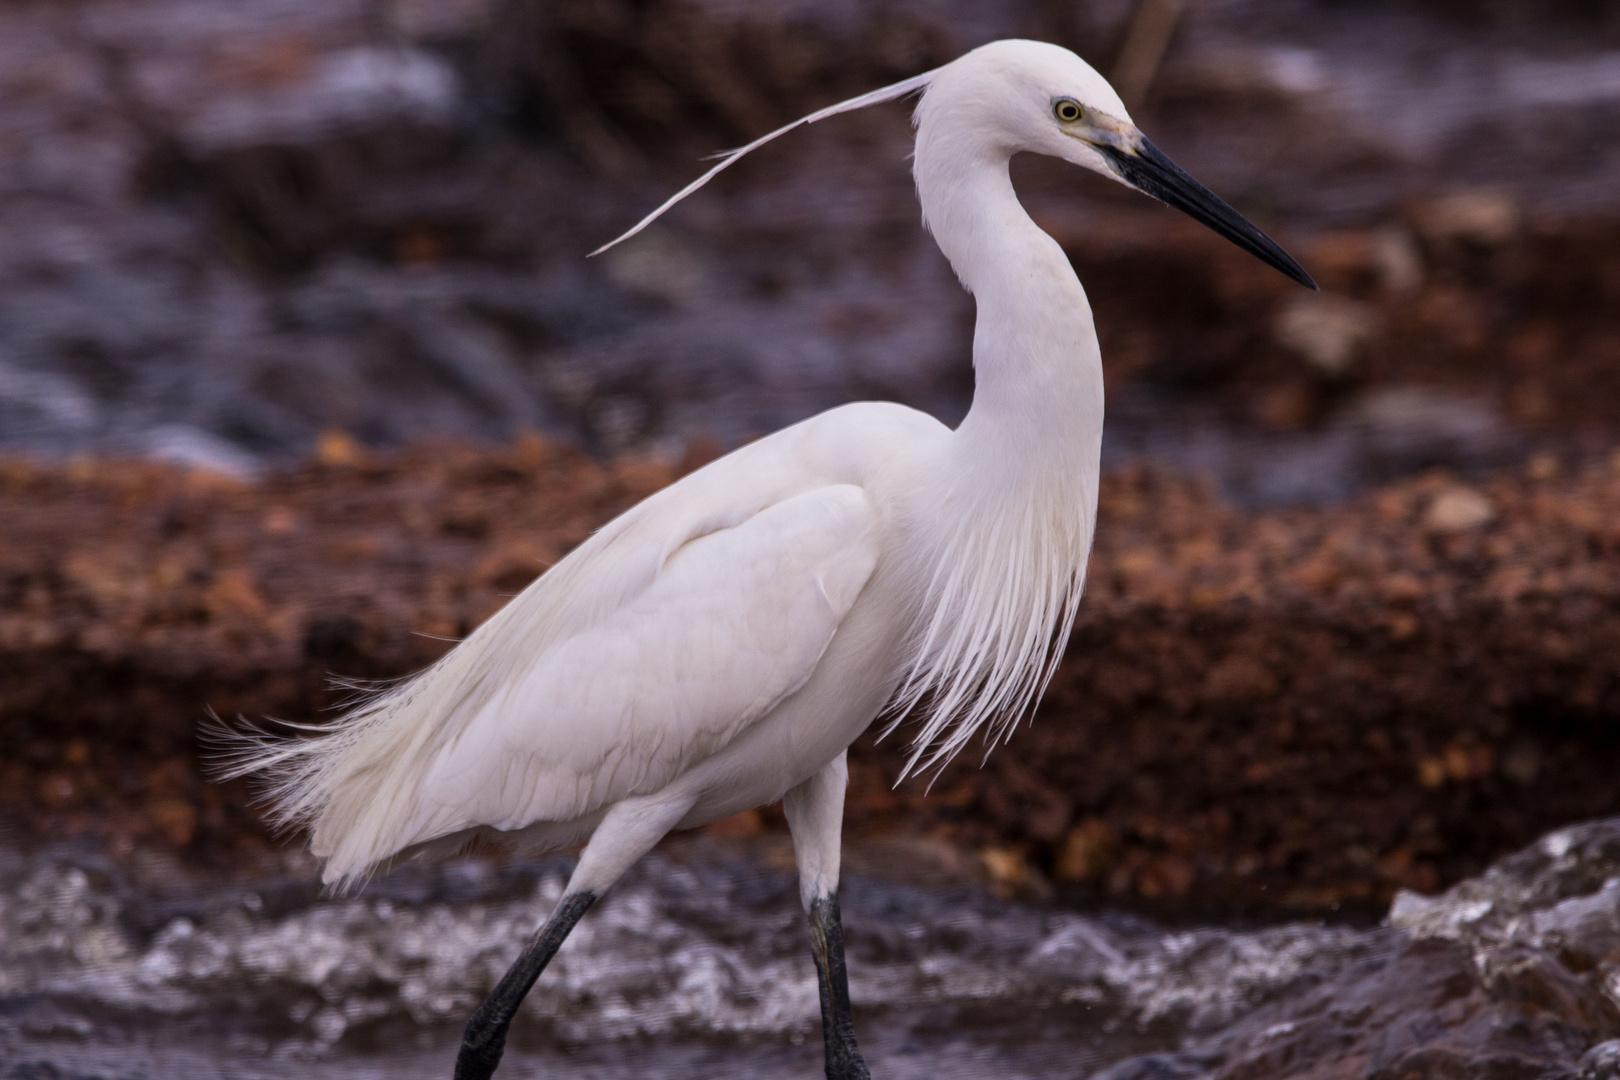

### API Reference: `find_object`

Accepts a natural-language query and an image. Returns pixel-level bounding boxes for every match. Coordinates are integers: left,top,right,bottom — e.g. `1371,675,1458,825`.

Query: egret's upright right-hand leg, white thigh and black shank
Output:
782,755,872,1080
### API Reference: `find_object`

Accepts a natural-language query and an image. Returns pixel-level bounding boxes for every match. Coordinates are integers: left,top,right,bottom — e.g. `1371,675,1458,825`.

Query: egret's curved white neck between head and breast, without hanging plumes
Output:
917,143,1103,485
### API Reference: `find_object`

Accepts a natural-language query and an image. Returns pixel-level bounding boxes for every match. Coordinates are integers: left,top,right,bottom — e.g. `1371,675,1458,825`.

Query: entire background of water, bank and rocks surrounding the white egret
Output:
9,0,1620,1080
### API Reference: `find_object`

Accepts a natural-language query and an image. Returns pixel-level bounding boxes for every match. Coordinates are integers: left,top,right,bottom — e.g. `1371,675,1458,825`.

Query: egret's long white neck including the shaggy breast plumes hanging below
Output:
896,122,1103,769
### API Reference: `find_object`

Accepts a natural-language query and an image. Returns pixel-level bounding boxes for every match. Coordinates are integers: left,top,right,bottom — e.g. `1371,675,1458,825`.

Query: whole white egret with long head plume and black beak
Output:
218,40,1314,1080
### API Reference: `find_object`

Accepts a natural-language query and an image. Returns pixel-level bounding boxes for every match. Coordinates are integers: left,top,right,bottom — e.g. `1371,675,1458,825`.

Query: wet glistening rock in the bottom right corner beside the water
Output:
1179,819,1620,1078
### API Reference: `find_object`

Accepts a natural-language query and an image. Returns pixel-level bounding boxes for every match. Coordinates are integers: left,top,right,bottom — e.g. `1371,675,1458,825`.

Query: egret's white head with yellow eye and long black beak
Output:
917,40,1315,288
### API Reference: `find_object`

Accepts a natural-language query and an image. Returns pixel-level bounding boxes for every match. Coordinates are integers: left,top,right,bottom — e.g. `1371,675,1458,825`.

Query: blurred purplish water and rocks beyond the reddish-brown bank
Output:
9,0,1620,504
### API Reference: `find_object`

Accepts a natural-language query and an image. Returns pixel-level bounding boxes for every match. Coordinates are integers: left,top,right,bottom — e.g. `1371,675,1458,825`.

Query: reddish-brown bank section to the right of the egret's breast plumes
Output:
855,459,1620,910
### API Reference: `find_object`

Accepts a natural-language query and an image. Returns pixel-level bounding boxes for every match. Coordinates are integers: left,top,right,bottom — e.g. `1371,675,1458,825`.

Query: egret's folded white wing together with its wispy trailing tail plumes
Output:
227,476,880,886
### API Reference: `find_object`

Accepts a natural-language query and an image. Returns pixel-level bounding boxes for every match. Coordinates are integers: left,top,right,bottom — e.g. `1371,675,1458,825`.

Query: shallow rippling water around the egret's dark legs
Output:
0,853,1393,1080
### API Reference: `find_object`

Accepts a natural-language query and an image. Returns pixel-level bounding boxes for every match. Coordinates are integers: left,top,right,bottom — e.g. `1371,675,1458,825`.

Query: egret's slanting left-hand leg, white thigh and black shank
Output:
455,795,692,1080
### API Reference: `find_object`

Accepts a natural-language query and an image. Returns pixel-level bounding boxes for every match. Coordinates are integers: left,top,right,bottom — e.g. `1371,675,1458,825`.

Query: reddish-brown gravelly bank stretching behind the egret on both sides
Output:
9,436,1620,916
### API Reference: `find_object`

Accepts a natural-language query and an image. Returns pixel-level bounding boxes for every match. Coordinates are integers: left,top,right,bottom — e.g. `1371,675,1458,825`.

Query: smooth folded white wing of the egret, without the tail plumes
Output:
407,484,878,842
